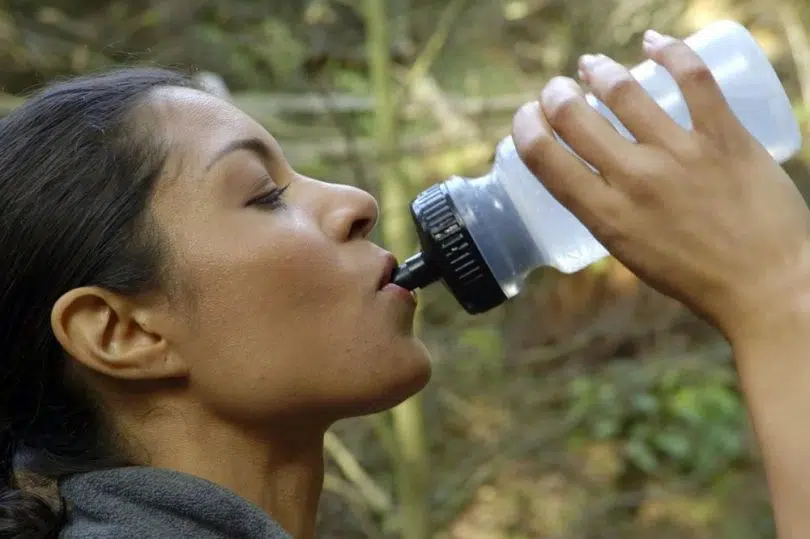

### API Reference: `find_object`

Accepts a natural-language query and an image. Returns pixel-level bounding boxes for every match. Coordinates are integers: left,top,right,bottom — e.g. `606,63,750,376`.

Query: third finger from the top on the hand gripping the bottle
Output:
540,77,635,173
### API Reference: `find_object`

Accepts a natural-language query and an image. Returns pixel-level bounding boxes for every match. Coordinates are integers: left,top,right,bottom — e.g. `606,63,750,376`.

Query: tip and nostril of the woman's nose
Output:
324,184,380,241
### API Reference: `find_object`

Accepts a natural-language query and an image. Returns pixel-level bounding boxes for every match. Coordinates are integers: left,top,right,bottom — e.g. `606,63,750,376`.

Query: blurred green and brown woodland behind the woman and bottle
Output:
0,0,810,539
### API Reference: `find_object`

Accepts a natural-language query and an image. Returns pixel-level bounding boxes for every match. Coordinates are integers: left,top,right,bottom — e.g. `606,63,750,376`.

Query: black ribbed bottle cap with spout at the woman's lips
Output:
393,183,507,314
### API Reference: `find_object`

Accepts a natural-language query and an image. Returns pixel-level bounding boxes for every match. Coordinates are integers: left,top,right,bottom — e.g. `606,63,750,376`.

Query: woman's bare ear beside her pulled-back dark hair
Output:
51,287,189,380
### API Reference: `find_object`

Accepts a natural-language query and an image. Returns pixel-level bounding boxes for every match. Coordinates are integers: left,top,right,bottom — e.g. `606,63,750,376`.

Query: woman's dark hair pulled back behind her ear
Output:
0,69,189,539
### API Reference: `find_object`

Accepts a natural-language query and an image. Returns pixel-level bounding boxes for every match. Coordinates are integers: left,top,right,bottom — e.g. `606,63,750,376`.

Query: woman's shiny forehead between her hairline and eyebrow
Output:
145,87,275,167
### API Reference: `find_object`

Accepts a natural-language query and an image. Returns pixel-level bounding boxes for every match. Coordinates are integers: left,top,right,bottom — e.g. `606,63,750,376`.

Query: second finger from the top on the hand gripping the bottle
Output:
579,54,689,147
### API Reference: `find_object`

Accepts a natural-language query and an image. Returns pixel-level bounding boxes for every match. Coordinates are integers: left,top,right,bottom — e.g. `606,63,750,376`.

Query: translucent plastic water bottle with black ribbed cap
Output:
392,21,801,314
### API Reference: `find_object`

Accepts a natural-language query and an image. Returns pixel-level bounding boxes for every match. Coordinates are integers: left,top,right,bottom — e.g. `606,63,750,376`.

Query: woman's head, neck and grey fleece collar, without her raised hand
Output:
0,70,430,539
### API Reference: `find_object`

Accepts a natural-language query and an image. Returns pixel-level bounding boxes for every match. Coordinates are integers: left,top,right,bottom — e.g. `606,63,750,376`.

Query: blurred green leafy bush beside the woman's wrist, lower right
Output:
569,362,750,480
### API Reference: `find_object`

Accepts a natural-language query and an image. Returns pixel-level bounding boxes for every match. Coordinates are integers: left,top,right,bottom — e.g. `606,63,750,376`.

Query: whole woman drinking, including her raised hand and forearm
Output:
0,28,810,538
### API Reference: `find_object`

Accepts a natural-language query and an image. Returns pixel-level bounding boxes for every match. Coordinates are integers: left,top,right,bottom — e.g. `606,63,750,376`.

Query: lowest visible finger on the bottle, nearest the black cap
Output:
512,101,620,227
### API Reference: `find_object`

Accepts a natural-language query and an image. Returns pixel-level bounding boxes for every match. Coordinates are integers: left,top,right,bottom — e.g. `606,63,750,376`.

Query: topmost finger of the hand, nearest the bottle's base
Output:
644,30,740,139
